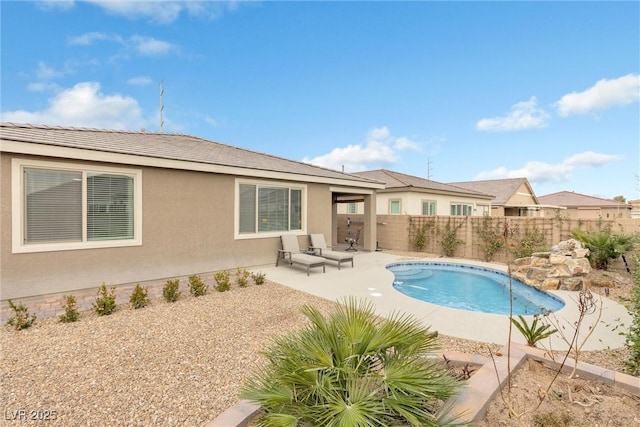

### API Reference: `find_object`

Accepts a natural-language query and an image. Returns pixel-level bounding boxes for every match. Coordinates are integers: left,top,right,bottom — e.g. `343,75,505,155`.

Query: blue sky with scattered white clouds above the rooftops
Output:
0,0,640,200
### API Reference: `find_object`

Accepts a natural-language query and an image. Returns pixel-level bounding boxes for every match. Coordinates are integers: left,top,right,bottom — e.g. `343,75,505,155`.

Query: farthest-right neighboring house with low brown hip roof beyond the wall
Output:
538,191,632,219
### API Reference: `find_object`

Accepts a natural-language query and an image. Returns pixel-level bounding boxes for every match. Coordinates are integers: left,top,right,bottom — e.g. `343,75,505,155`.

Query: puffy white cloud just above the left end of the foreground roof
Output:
2,82,145,129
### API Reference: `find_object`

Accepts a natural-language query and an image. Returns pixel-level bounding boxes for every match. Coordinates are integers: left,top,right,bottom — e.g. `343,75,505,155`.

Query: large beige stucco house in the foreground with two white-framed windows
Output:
0,123,383,301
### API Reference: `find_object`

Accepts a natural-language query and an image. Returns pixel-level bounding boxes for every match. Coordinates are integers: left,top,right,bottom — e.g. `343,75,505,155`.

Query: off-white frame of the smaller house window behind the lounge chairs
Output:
233,179,307,240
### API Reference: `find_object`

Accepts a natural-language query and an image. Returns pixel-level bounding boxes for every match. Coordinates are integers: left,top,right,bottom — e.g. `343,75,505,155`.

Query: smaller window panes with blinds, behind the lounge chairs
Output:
238,184,303,234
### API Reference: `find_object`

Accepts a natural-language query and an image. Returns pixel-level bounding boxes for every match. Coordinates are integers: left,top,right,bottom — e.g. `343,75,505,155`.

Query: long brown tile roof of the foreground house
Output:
0,123,372,183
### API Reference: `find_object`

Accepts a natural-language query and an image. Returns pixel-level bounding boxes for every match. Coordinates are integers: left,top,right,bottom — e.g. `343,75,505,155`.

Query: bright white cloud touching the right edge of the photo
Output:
554,74,640,117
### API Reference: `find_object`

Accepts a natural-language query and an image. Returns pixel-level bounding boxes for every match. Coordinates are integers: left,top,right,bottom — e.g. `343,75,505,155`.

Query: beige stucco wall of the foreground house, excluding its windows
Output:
0,153,332,300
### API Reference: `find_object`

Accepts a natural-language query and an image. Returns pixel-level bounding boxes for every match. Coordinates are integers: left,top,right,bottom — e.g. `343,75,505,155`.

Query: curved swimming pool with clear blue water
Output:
387,262,564,315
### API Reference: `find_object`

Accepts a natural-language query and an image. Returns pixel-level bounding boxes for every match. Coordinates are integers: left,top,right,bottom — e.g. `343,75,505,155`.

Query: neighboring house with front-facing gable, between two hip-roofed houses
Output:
449,178,541,217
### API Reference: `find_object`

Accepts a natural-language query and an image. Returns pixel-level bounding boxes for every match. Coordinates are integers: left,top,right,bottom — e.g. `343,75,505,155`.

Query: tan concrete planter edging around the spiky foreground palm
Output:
205,343,640,427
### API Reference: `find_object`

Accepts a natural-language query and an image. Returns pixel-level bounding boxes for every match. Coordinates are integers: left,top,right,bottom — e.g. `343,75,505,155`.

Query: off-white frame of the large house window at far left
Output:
11,158,142,253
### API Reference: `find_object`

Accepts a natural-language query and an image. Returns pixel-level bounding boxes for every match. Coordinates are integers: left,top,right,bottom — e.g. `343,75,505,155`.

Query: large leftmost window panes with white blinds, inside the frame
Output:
23,167,134,244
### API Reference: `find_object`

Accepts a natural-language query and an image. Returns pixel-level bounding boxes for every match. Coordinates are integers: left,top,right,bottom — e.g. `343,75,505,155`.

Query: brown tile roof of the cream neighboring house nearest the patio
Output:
354,169,493,199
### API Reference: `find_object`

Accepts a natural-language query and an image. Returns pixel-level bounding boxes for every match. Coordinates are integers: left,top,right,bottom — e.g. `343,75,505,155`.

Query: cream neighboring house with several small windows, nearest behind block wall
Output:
339,169,493,216
